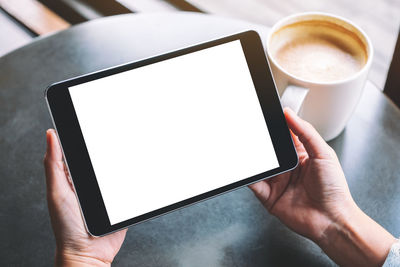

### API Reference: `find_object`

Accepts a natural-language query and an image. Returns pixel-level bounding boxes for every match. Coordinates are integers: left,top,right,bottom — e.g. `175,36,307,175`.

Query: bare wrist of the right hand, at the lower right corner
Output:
317,203,395,266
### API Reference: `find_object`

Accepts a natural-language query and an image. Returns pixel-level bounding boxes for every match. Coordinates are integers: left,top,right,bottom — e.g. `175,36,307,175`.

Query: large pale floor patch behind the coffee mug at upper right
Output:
188,0,400,88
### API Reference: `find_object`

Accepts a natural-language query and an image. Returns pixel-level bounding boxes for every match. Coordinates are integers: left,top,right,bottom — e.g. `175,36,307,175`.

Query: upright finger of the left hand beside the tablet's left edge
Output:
44,129,70,197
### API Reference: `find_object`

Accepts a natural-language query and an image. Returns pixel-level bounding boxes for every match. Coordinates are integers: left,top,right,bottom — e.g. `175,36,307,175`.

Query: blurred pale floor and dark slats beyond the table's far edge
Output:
0,0,400,88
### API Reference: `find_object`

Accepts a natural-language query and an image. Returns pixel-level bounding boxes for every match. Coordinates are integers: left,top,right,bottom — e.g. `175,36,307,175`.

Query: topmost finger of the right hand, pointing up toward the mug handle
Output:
284,108,330,157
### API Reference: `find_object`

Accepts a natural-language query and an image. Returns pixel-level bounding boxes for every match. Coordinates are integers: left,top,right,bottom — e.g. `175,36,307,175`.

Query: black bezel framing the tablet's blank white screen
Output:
45,31,298,236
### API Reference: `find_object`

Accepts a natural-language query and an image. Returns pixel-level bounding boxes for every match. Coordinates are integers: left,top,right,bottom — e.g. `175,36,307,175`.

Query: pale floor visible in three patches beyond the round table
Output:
0,0,400,88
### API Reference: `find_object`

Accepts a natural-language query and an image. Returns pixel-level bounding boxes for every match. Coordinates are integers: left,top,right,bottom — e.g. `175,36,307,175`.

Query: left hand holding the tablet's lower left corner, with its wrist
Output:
44,129,127,266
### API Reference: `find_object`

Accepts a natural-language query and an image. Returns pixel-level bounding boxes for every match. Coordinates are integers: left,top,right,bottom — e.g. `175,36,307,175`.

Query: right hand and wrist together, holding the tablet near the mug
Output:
249,109,395,266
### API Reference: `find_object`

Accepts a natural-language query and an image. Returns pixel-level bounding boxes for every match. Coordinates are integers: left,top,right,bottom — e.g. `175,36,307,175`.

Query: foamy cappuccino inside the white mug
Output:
269,20,368,82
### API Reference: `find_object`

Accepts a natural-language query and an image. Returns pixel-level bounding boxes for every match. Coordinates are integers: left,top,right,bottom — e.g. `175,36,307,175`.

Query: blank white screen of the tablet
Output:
69,41,279,224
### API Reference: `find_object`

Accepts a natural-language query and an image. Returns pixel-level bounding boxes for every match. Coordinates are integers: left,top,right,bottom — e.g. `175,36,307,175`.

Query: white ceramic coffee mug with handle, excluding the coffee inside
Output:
266,12,373,141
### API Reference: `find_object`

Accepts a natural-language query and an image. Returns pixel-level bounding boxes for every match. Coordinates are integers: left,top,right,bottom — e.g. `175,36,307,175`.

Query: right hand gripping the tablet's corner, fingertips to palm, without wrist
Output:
250,109,354,241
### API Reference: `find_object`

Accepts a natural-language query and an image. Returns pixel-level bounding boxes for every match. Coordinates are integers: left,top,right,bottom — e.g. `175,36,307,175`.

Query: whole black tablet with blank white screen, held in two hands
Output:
45,31,298,236
